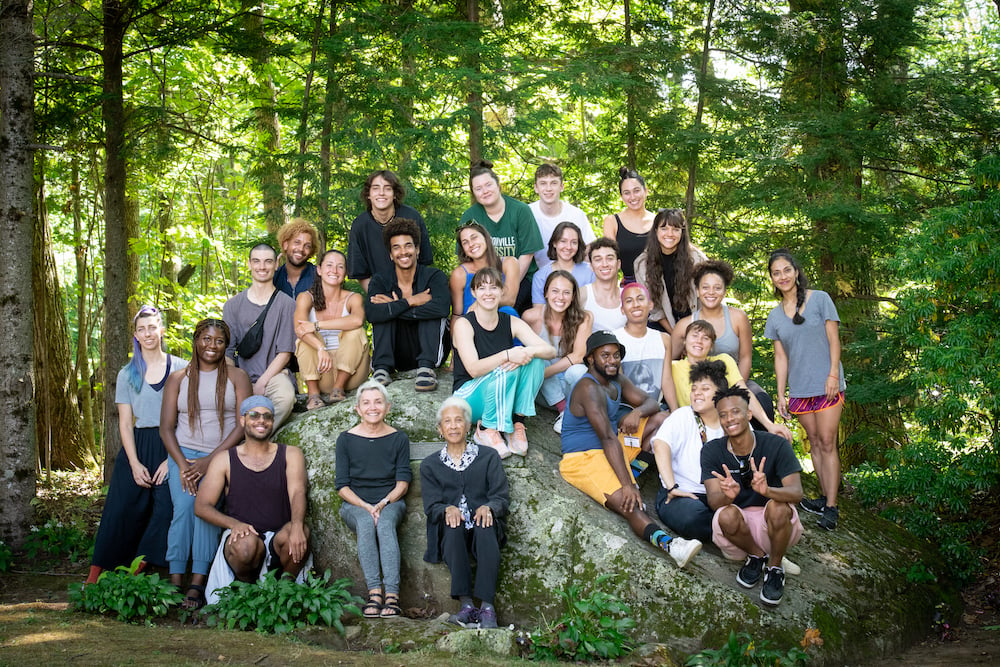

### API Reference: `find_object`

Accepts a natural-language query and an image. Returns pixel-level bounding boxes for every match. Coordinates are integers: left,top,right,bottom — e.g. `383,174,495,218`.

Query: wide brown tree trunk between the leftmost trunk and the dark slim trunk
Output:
31,167,94,470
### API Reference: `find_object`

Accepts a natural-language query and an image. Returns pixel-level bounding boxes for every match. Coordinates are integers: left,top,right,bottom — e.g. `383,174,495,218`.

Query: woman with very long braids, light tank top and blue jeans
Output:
160,319,253,609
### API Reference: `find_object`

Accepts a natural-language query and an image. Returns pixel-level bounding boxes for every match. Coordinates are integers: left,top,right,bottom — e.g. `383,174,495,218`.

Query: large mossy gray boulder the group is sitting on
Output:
277,374,957,665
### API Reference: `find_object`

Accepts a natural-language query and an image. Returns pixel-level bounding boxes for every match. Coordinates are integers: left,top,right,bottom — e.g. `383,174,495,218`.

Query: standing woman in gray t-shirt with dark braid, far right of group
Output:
764,250,846,530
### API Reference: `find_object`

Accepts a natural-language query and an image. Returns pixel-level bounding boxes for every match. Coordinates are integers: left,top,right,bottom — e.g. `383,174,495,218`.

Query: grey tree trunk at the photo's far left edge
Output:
0,0,35,546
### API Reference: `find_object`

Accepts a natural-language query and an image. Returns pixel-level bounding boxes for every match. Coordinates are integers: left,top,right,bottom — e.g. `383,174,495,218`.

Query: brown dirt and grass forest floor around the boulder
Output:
0,476,1000,667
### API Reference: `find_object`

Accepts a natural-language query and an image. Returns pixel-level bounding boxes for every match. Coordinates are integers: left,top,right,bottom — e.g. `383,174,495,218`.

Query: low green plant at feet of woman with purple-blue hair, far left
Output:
68,556,183,623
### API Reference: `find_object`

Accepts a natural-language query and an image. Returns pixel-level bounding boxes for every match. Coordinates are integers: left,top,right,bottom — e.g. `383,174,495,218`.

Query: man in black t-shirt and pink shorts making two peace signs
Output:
701,387,802,605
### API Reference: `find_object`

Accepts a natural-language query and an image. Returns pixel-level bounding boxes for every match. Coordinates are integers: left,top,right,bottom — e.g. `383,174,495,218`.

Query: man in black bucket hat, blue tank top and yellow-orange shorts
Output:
559,331,701,567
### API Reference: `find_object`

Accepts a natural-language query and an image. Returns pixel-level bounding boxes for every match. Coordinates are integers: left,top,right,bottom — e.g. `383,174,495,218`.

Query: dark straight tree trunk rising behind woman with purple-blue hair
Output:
101,0,136,480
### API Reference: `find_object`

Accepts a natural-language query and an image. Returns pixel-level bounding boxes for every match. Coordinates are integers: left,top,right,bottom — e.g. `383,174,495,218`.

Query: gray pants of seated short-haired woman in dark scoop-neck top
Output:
340,500,406,595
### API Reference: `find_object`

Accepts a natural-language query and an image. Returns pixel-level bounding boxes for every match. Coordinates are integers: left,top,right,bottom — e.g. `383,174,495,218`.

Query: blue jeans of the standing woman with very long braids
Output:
167,447,225,574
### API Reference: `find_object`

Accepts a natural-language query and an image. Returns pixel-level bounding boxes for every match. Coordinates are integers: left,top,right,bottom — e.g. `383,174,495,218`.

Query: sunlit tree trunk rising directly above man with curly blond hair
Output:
243,0,285,234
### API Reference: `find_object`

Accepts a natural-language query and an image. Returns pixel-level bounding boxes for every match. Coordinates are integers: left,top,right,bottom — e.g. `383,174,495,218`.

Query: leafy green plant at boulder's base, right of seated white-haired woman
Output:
529,575,635,661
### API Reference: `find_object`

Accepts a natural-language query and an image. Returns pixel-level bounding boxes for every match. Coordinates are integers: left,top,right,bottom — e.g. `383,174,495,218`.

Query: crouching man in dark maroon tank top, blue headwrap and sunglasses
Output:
194,396,312,604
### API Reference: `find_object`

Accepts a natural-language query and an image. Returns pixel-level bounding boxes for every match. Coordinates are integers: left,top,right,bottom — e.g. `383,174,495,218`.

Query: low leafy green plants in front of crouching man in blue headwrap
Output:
204,570,362,634
